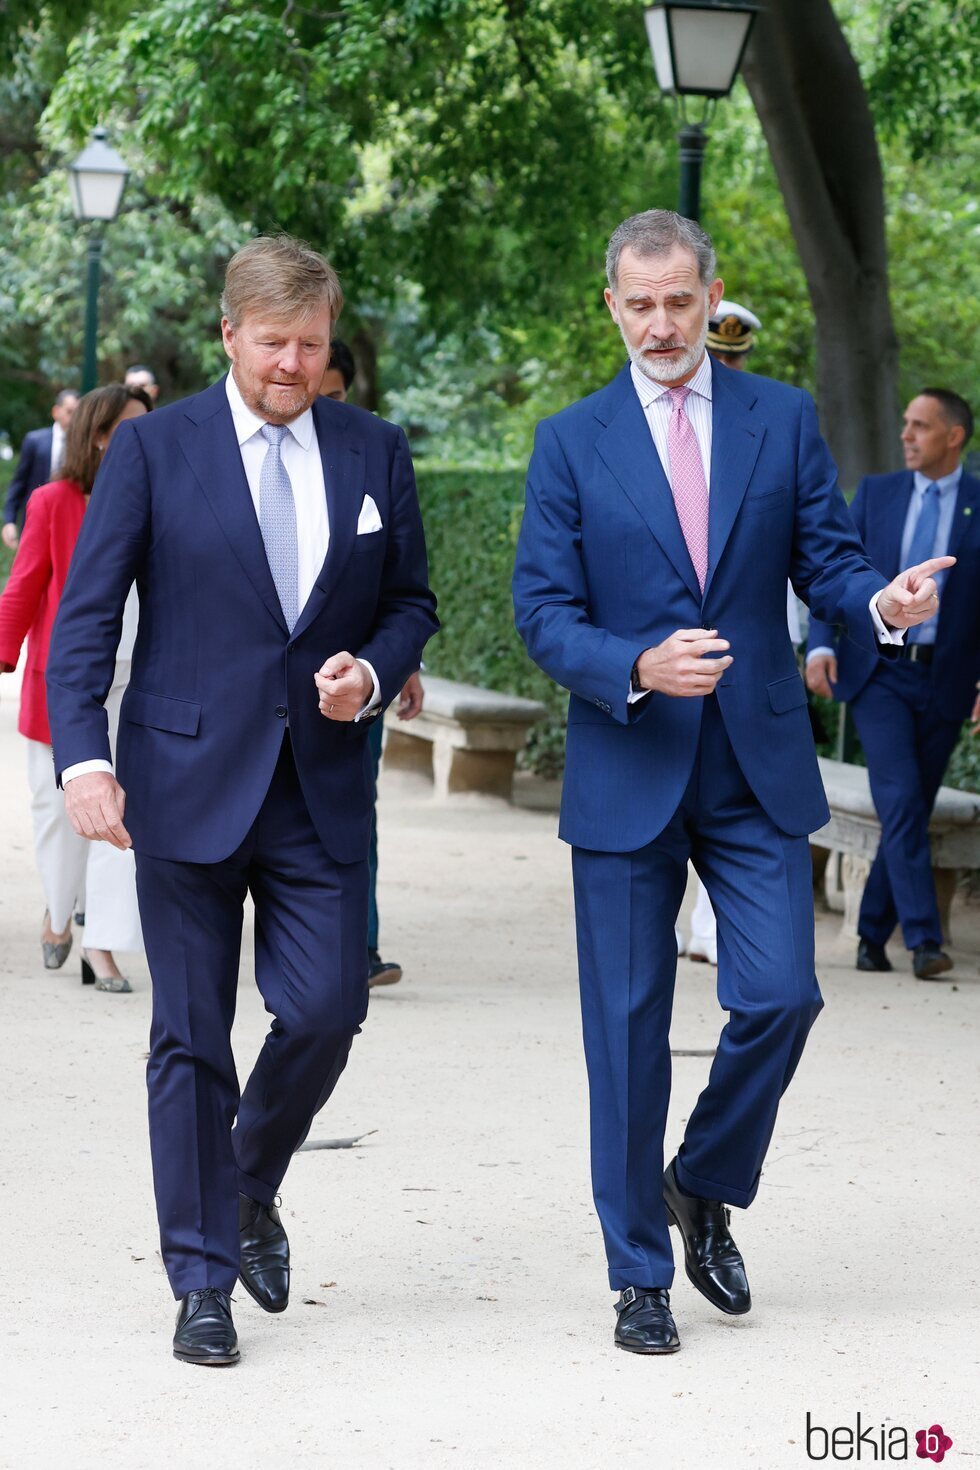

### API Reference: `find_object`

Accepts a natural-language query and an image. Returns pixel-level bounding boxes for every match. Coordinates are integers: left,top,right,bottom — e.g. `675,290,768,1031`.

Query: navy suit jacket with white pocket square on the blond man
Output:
47,382,438,863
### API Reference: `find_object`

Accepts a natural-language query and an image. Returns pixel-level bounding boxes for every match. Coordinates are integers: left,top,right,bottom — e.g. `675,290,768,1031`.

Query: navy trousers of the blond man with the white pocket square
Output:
137,732,367,1298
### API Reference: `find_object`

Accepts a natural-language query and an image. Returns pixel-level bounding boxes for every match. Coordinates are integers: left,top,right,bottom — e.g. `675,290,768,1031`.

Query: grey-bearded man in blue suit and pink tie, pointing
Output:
514,210,946,1352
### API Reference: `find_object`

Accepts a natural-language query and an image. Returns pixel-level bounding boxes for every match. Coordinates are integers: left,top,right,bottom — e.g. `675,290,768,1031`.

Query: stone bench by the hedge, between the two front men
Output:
385,673,547,801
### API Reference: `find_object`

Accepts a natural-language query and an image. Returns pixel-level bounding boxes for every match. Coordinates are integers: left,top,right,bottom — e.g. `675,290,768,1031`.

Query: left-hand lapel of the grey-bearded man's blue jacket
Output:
595,368,701,601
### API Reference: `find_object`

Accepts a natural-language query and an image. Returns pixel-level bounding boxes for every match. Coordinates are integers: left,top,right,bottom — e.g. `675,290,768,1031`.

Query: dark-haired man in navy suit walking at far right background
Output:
807,388,980,980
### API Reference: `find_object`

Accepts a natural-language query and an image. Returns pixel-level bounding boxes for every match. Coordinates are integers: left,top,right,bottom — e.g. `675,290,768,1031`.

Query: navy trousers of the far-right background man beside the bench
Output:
849,662,961,950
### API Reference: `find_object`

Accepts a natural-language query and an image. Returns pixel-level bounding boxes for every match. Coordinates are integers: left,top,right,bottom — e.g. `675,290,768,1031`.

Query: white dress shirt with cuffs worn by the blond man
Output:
62,372,381,786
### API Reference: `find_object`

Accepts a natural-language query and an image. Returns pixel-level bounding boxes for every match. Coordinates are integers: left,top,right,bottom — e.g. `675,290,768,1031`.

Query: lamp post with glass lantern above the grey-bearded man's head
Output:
644,0,761,219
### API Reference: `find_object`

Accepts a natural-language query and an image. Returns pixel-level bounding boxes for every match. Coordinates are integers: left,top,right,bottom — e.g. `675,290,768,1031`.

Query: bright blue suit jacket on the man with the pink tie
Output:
514,354,886,851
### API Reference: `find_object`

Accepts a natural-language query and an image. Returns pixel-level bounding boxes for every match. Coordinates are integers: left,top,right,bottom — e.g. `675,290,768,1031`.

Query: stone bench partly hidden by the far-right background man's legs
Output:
810,757,980,944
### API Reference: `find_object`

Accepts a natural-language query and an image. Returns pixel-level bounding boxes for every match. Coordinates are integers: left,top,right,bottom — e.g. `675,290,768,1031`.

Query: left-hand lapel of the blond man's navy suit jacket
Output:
178,379,288,632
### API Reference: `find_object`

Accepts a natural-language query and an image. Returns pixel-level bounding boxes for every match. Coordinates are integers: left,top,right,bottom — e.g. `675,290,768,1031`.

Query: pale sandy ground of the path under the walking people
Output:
0,667,980,1470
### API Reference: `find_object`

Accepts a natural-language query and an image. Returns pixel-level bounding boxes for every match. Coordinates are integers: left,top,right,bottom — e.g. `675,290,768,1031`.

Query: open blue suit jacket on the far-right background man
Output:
807,470,980,720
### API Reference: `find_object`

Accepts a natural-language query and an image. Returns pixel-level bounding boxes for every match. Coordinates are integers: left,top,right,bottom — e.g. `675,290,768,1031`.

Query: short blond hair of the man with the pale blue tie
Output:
222,235,344,326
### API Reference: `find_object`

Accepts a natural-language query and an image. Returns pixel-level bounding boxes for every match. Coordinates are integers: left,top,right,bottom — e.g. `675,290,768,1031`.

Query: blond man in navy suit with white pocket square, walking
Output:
47,237,438,1364
